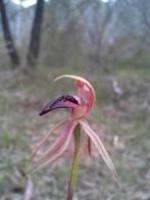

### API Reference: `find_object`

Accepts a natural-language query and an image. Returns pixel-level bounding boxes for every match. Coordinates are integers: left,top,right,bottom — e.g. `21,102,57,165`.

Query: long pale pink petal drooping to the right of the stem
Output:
80,120,118,182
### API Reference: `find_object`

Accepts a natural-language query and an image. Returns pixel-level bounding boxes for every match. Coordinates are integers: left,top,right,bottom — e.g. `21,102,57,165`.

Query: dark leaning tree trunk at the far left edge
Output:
0,0,20,67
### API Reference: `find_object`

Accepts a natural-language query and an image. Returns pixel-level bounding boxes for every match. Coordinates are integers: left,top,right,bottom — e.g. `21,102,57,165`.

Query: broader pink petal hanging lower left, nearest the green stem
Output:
33,121,77,171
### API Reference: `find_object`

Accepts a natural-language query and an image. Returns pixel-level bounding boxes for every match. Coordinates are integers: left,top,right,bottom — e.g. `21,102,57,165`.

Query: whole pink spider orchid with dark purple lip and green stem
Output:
32,75,117,200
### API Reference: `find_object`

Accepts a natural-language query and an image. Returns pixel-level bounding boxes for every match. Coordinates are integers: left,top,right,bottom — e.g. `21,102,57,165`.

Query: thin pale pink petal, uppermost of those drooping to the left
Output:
31,120,67,159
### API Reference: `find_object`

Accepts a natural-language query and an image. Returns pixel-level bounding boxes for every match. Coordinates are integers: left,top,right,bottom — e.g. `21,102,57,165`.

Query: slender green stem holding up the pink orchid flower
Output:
67,125,81,200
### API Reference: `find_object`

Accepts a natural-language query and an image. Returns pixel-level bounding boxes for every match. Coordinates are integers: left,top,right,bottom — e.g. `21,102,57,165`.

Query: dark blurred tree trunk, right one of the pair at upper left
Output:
27,0,45,66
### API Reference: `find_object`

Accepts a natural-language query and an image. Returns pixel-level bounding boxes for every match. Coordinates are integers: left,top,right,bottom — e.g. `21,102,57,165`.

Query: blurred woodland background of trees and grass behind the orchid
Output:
0,0,150,200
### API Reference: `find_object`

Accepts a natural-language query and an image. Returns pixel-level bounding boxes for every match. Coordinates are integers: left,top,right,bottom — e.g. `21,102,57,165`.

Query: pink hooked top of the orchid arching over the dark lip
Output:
55,74,95,111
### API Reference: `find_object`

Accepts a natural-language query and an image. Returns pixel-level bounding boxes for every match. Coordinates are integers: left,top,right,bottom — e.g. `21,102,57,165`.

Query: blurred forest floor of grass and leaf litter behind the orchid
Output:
0,68,150,200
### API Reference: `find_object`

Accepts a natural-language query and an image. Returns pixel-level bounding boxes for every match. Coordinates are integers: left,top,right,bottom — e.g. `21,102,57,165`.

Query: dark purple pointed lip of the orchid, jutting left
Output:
39,95,79,116
